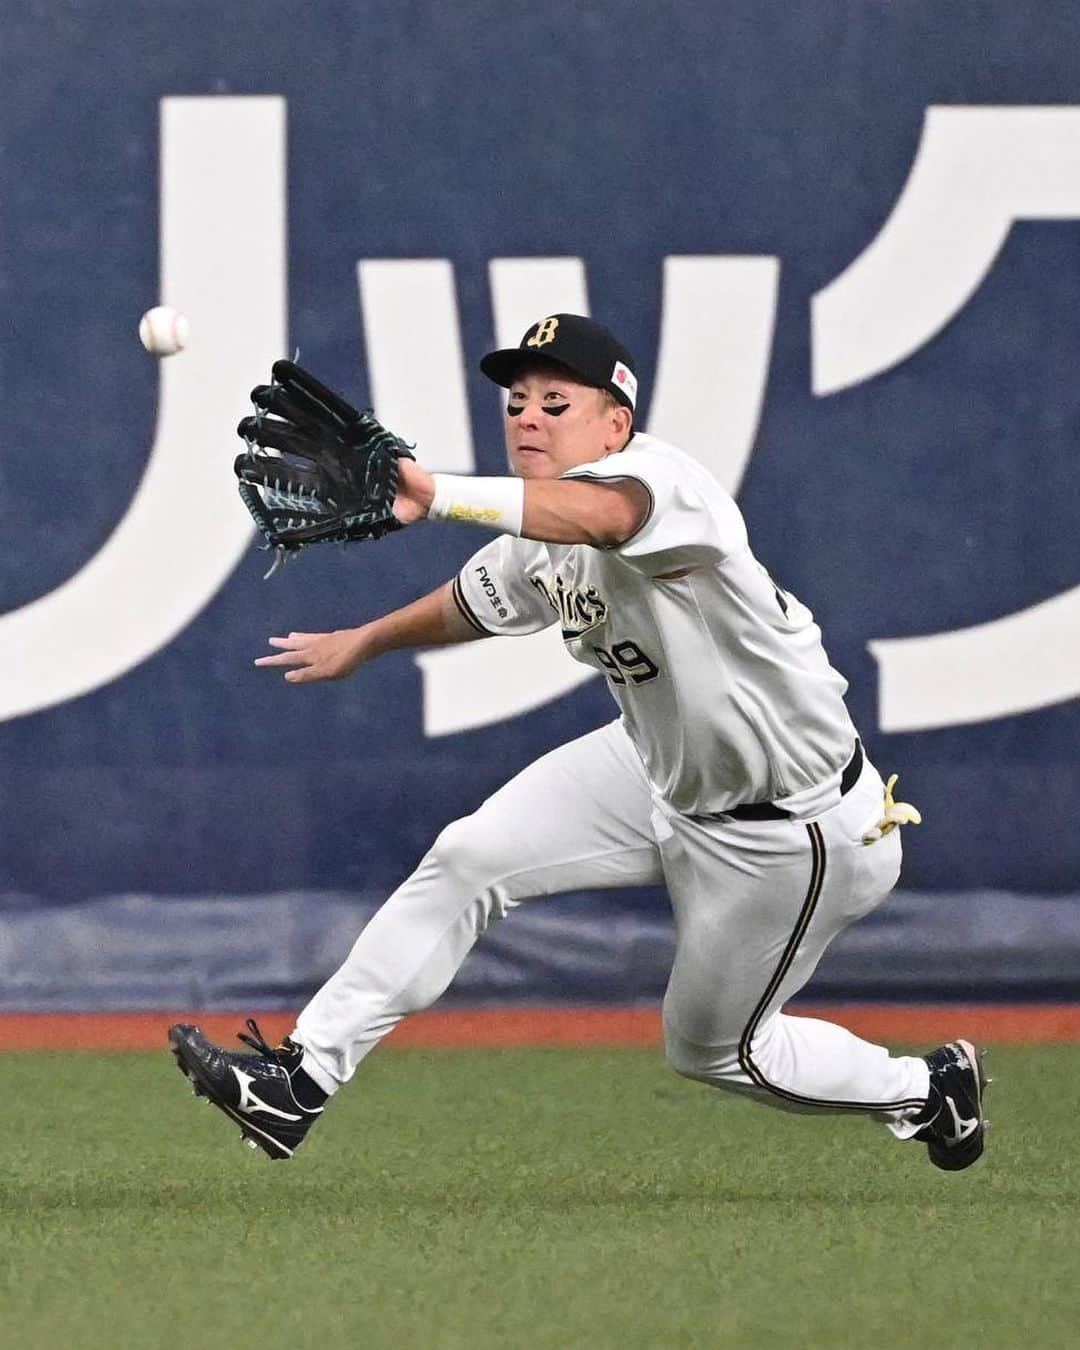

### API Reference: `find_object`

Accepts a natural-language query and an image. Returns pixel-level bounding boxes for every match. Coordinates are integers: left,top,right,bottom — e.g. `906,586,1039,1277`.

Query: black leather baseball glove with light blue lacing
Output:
234,360,413,576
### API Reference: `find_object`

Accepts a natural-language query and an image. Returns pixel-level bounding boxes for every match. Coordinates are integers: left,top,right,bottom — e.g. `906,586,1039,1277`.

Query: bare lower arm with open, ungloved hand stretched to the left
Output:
255,582,486,684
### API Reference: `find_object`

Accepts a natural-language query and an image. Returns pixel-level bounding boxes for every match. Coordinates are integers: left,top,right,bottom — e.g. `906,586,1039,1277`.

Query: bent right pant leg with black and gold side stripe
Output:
660,765,929,1135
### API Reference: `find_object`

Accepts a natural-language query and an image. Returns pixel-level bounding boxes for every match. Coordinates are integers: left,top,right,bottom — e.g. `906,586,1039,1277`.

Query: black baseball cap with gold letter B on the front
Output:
481,315,637,412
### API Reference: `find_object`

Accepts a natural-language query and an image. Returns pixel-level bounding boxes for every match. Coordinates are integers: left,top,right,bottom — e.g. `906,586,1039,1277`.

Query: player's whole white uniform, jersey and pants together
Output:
296,436,930,1138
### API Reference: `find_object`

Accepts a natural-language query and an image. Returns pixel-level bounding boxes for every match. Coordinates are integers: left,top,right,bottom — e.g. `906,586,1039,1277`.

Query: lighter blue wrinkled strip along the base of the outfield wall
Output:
0,891,1080,1014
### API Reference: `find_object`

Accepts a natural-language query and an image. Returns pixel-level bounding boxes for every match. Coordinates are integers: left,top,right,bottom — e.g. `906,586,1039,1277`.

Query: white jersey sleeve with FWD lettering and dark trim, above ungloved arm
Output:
454,535,558,637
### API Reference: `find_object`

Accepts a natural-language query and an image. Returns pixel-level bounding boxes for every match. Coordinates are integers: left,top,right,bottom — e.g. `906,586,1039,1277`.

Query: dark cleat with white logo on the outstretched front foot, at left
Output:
169,1018,325,1158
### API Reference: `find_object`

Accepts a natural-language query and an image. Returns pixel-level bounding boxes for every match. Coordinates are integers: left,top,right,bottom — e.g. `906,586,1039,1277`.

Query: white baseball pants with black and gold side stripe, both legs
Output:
294,721,929,1138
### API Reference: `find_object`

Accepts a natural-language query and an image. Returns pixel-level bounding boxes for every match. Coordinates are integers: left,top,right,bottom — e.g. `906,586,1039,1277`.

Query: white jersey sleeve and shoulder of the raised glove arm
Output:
563,437,747,576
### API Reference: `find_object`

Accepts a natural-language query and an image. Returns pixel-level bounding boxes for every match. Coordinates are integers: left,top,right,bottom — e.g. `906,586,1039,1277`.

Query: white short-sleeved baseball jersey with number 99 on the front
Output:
454,433,855,817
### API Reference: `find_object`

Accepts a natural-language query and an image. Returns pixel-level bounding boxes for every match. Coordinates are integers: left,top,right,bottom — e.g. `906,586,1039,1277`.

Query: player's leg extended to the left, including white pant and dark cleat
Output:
169,722,662,1158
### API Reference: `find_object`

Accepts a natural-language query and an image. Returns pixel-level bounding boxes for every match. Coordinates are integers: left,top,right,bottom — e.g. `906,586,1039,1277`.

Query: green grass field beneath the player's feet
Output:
0,1046,1080,1350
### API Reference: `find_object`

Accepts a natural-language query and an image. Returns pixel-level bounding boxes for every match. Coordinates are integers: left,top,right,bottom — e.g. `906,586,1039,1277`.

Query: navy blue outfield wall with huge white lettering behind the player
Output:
0,0,1080,1010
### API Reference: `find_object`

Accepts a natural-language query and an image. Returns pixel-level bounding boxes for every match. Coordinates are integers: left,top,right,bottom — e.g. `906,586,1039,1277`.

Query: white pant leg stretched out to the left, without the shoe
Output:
296,722,662,1091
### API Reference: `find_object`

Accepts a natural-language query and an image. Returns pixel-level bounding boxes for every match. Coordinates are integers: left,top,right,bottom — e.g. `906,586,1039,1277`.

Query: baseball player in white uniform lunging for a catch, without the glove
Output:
170,315,987,1170
